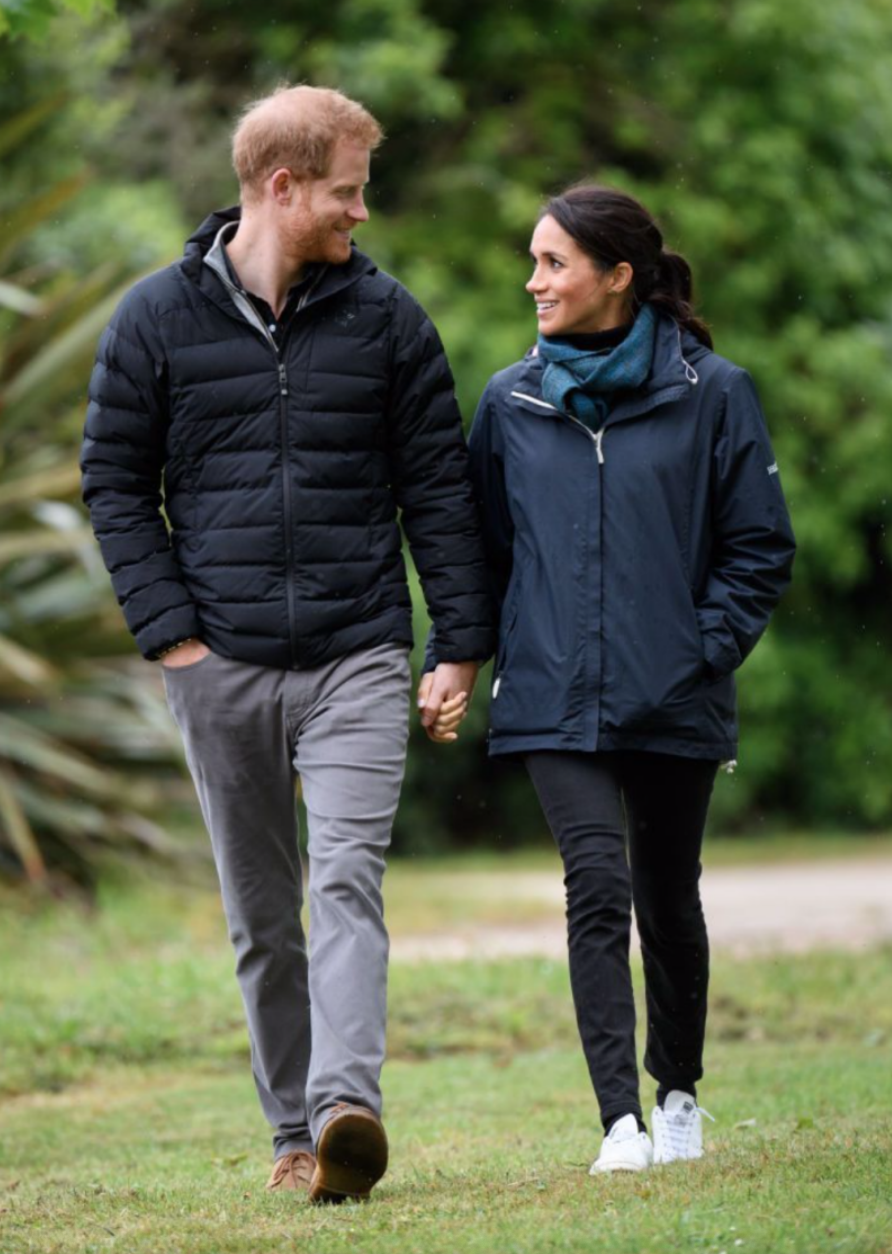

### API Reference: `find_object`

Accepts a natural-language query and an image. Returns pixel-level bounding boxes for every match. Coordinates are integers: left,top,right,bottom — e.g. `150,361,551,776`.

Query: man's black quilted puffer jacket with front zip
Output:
82,209,492,668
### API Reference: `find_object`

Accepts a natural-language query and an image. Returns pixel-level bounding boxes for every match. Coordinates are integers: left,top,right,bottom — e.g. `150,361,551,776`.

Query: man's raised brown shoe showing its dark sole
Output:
310,1102,388,1203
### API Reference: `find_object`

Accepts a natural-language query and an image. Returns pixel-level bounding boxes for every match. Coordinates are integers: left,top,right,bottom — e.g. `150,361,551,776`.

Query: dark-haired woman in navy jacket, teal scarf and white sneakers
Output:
432,186,794,1174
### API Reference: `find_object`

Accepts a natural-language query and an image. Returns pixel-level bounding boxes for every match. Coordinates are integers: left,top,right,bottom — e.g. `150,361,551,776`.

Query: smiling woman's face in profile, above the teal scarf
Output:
527,216,632,336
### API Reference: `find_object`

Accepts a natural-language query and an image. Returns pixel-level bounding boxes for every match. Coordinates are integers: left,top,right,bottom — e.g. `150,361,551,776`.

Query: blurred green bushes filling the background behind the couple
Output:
0,0,892,872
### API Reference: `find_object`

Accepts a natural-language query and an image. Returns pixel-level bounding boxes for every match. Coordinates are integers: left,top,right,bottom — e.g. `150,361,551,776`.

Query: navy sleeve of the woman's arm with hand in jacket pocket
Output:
696,370,795,678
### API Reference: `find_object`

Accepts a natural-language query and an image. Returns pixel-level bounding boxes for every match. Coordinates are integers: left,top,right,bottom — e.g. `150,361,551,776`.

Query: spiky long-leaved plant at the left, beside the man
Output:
0,144,193,880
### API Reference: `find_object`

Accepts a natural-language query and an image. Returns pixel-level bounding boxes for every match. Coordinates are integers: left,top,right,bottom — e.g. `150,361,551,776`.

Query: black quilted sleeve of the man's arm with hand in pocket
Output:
80,288,201,660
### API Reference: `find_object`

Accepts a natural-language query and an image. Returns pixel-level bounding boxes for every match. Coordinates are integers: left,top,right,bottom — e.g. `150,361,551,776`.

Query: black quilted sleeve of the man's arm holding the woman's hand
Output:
388,290,493,662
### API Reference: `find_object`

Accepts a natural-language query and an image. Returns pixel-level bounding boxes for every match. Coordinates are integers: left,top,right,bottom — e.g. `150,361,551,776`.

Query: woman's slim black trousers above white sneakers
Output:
524,751,718,1129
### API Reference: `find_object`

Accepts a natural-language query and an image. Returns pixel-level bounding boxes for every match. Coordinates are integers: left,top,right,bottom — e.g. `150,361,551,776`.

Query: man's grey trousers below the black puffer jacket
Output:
164,645,410,1157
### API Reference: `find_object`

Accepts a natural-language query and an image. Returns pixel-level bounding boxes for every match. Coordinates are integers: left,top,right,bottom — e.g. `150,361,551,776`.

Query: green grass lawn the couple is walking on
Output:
0,868,892,1254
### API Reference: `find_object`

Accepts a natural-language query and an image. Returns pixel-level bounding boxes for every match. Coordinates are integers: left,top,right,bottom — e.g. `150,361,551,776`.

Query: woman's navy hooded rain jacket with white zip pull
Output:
469,317,794,759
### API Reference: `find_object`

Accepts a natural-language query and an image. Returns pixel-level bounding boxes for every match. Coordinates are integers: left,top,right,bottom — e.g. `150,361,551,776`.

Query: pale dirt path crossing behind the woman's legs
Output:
391,858,892,962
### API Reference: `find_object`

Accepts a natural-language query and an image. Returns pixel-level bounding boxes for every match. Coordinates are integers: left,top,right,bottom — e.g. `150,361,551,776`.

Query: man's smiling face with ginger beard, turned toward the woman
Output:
282,139,371,266
